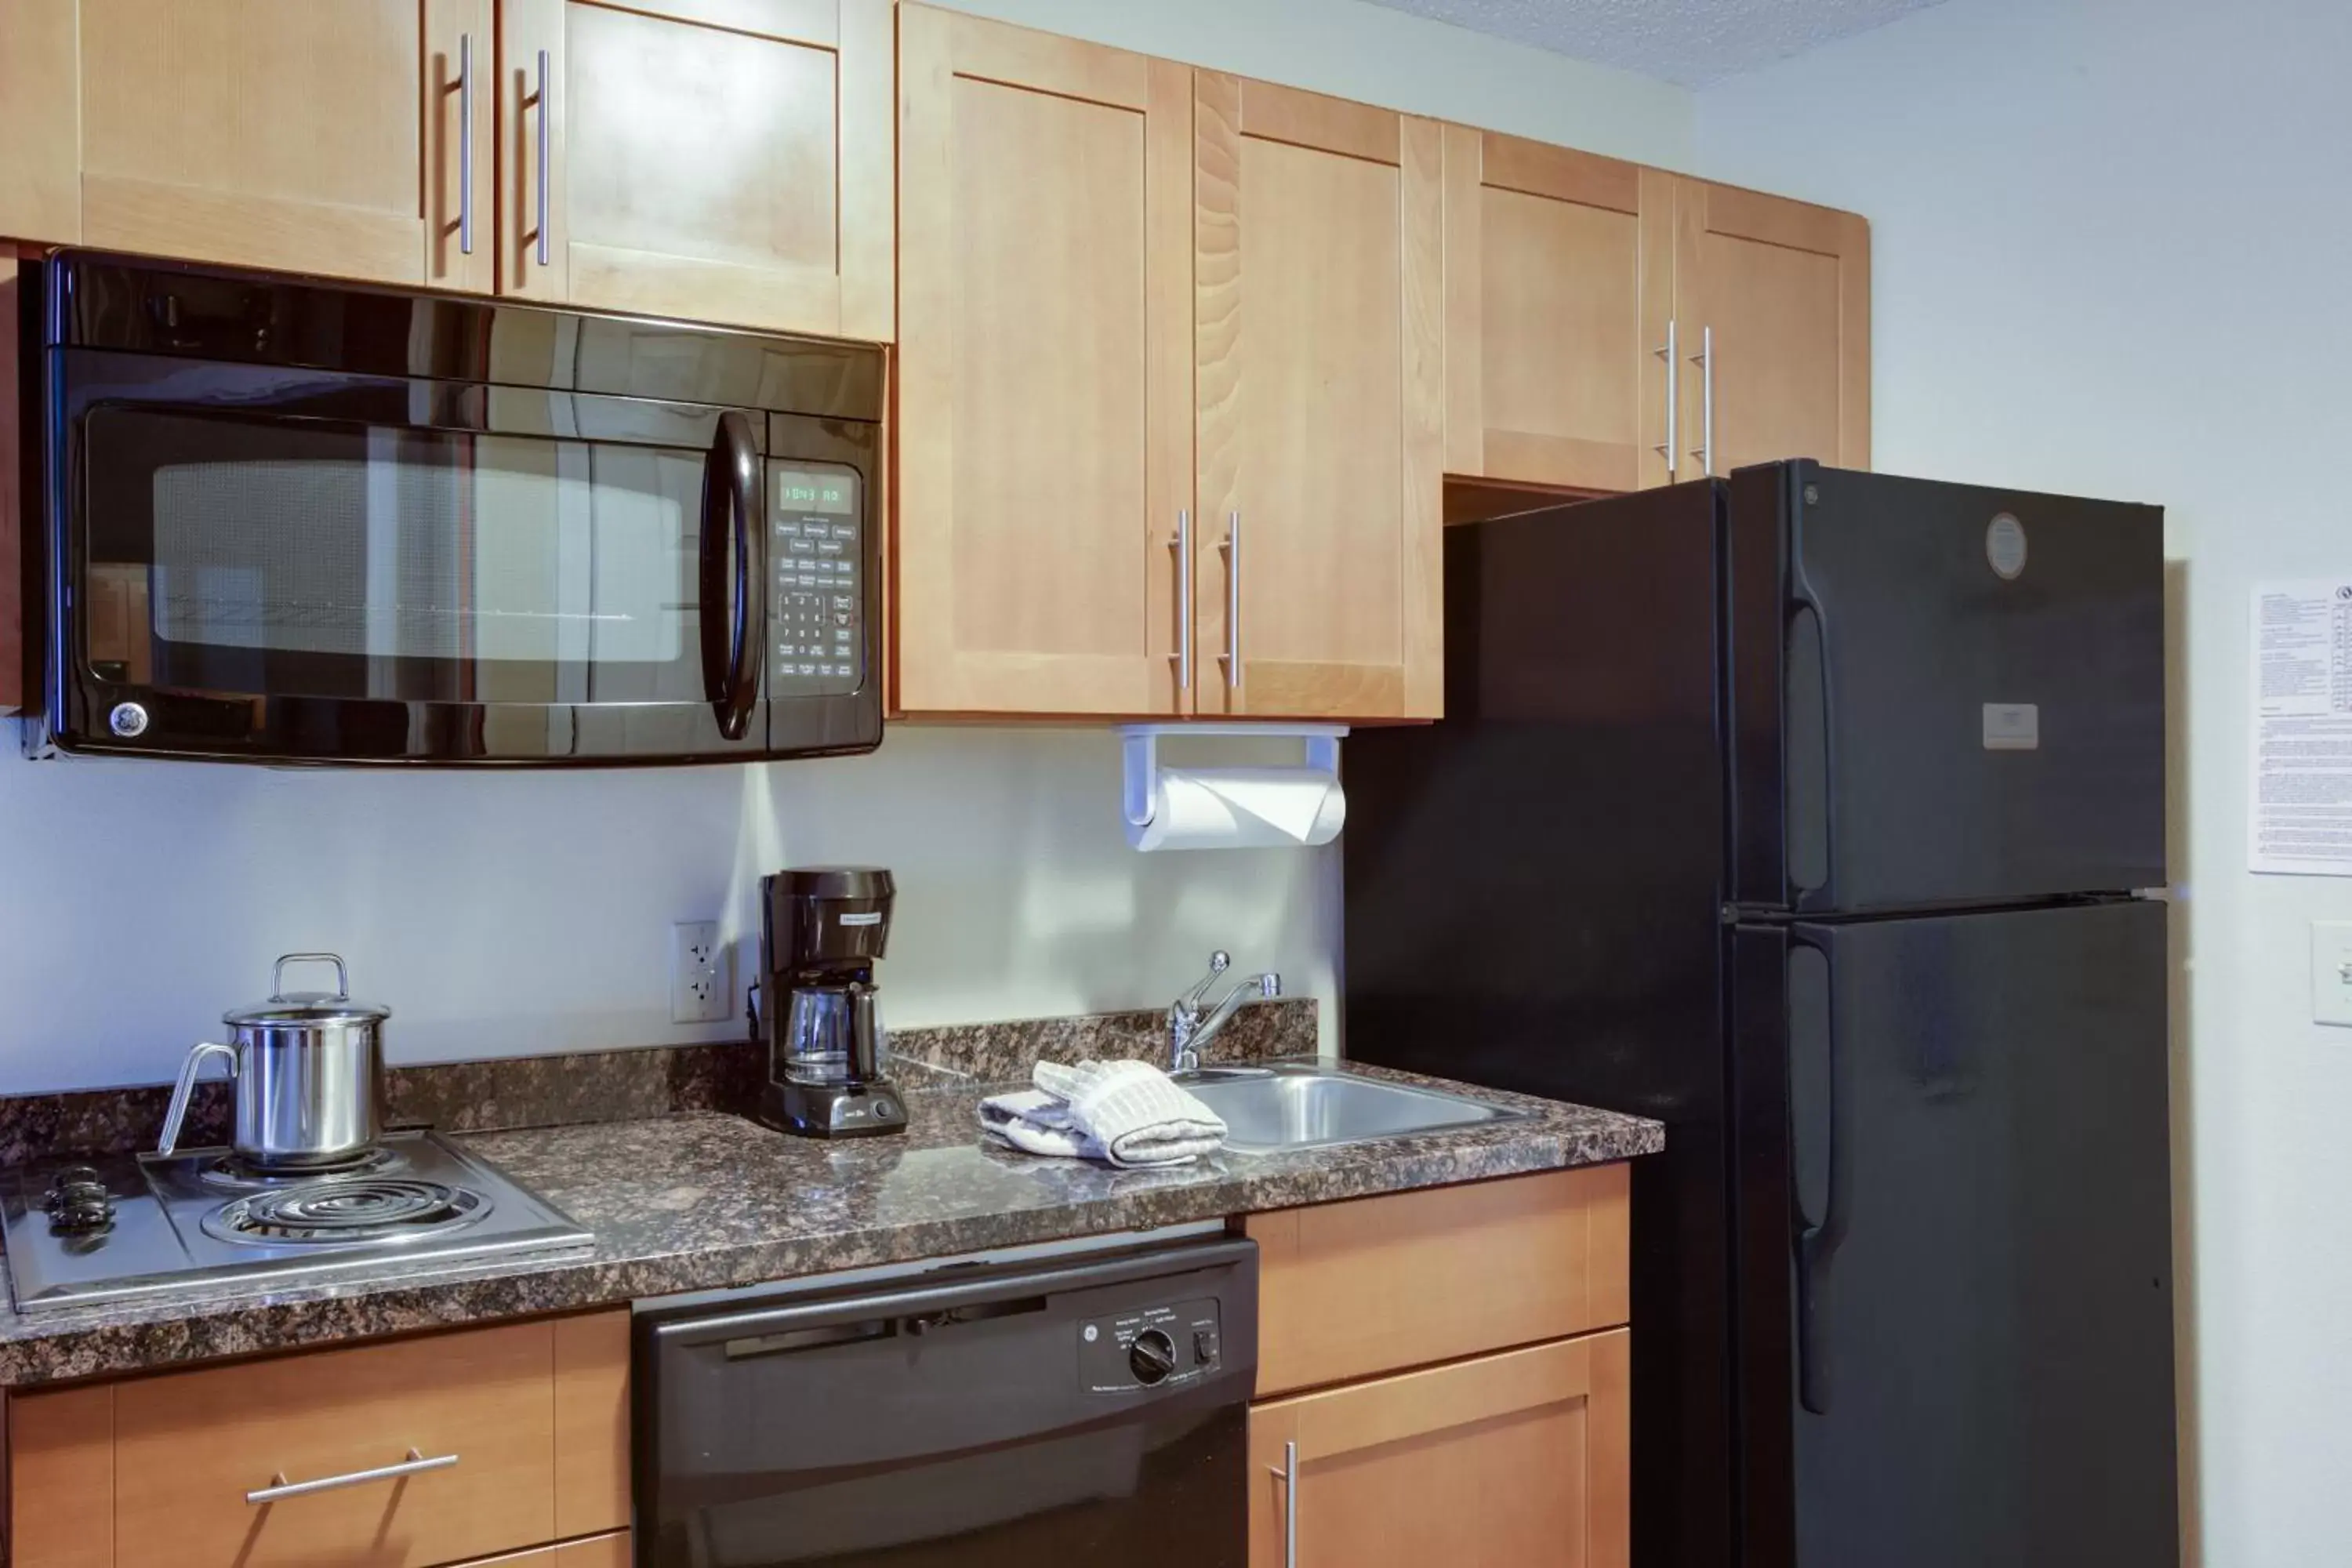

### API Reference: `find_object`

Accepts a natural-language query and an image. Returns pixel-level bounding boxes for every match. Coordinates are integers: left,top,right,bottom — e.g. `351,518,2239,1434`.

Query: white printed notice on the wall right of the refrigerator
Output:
2249,576,2352,877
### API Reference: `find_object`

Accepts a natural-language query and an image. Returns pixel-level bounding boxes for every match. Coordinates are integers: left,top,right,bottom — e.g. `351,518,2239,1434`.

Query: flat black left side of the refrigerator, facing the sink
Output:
1341,485,1733,1568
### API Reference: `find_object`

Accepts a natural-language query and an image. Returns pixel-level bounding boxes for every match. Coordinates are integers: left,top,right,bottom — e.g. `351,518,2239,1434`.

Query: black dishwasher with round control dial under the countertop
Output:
633,1236,1258,1568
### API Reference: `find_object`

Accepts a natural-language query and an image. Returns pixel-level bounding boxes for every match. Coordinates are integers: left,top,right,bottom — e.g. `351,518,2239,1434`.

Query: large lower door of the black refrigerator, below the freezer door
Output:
1733,902,2178,1568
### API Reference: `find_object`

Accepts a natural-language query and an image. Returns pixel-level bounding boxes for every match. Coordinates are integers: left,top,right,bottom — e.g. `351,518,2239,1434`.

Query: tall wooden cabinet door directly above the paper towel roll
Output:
1192,71,1444,720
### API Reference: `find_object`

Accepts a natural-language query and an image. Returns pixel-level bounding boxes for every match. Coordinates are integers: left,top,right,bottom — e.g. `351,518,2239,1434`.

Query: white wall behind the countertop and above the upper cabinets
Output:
0,0,1691,1093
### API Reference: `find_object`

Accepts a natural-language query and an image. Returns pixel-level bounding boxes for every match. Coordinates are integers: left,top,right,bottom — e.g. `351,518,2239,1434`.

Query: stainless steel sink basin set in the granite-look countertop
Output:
1178,1062,1526,1154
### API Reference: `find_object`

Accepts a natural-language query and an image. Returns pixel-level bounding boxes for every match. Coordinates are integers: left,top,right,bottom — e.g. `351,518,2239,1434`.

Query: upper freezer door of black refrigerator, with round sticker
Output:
1729,463,2166,912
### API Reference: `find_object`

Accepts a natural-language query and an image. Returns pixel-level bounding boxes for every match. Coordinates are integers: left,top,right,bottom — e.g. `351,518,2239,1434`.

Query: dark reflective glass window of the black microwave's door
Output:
85,409,706,703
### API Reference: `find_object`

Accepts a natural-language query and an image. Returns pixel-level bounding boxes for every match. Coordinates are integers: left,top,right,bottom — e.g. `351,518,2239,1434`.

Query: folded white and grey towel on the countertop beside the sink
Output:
981,1060,1225,1166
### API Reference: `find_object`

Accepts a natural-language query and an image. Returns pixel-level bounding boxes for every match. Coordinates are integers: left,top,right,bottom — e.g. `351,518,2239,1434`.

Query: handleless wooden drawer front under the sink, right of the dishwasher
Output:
1244,1163,1630,1399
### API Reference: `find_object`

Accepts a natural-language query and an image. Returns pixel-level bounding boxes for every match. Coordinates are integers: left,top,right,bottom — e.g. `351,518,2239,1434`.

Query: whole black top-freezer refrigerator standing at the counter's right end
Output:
1343,463,2178,1568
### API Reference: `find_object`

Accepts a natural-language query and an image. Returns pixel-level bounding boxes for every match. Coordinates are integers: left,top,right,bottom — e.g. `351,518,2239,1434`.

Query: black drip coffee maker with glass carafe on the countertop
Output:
753,865,906,1138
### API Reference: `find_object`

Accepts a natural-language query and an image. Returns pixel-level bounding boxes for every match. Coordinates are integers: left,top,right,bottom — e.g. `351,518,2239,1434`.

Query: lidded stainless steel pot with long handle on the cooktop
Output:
155,952,393,1168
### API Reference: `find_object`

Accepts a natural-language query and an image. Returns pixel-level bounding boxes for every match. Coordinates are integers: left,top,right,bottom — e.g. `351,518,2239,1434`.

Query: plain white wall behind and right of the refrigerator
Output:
1698,0,2352,1568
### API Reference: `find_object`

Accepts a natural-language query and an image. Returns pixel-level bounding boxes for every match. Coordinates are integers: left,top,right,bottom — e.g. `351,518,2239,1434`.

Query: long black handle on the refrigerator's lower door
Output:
1788,935,1849,1415
